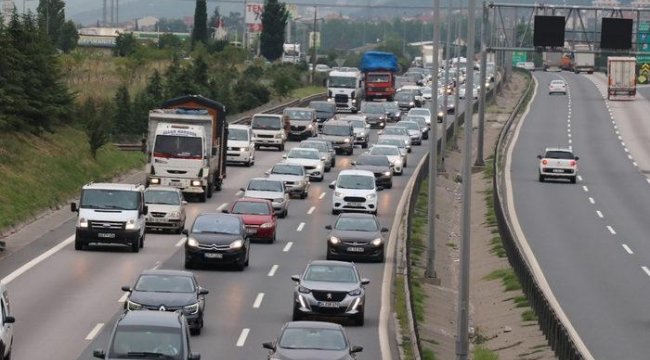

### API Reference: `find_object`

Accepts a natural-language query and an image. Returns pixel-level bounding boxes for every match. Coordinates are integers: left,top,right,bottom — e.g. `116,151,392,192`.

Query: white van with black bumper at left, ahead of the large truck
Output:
70,183,148,252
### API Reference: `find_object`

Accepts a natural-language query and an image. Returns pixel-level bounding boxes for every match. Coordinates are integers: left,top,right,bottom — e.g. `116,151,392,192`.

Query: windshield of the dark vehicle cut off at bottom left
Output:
107,325,184,360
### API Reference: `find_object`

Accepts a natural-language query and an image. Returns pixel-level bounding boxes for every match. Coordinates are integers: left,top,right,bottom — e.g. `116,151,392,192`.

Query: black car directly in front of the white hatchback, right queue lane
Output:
325,213,388,262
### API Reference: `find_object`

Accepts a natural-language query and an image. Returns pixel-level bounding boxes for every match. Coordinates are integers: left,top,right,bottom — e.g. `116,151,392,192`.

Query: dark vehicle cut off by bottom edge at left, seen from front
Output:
93,311,201,360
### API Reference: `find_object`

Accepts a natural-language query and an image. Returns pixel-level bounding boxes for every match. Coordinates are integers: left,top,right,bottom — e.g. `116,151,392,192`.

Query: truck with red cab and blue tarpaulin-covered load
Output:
359,51,399,101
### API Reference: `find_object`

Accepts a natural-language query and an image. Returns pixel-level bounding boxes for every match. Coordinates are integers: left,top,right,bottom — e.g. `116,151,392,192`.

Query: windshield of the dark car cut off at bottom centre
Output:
278,327,348,351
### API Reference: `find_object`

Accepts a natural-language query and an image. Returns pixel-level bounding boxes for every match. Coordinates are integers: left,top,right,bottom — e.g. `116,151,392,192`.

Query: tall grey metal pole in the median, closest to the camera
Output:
456,0,476,360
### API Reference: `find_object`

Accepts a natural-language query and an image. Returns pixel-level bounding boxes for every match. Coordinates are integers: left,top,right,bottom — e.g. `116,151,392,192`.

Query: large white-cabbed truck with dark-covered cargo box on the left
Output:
146,95,228,202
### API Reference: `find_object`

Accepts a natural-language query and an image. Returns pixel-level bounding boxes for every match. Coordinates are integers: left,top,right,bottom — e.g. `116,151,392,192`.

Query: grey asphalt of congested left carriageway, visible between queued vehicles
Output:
0,101,462,360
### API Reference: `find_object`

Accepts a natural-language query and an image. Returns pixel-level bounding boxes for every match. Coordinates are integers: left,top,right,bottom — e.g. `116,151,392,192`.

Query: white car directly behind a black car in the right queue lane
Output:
330,170,382,215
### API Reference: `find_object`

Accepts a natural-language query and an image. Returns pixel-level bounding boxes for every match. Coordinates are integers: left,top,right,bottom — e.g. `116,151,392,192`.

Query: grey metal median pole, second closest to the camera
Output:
426,0,444,279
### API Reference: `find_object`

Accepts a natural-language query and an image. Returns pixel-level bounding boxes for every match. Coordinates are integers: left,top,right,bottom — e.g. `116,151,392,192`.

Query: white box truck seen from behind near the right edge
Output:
607,56,636,100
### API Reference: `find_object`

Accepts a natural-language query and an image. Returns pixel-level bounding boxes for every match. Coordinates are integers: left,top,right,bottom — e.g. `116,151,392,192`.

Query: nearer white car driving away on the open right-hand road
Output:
537,147,579,184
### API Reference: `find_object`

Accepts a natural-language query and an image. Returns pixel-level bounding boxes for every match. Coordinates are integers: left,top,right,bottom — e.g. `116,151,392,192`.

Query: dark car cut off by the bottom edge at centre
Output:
262,321,363,360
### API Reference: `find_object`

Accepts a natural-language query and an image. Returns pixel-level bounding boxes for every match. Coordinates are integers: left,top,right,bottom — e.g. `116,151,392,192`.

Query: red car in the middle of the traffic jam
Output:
223,198,278,244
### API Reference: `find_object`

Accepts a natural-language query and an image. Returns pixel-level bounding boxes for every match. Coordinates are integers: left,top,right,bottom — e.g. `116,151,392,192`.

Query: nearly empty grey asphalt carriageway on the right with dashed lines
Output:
510,72,650,359
